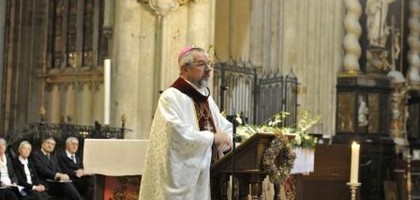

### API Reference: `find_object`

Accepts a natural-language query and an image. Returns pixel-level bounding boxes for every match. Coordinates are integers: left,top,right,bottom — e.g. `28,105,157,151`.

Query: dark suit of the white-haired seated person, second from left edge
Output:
14,157,49,200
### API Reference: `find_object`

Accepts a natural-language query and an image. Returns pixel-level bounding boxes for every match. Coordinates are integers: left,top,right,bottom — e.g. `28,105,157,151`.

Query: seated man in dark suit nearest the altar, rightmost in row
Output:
57,137,94,200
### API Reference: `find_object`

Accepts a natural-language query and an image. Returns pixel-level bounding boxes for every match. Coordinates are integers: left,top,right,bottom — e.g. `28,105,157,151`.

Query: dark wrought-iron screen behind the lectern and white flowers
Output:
213,60,298,125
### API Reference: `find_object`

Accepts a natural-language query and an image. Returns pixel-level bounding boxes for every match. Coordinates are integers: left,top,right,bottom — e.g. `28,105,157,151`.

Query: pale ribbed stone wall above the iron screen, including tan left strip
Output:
215,0,344,135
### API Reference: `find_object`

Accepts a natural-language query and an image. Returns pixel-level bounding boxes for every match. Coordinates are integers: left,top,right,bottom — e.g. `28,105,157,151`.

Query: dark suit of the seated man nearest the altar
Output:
57,151,94,200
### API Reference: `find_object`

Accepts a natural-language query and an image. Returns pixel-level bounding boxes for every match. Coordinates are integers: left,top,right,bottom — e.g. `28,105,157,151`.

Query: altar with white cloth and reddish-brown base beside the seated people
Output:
83,139,148,199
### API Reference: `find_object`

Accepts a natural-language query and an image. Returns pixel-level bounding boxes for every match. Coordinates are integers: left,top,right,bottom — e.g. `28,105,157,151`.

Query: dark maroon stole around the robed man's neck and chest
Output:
171,78,219,163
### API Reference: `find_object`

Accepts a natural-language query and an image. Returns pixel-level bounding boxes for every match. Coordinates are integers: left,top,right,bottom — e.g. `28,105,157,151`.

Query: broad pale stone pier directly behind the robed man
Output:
111,1,215,139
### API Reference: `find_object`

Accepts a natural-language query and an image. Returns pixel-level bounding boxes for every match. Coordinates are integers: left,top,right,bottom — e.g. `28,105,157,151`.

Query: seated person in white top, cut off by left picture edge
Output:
0,138,19,200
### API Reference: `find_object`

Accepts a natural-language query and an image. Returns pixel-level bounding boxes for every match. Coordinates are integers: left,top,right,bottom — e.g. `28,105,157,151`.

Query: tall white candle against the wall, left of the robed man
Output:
104,59,111,125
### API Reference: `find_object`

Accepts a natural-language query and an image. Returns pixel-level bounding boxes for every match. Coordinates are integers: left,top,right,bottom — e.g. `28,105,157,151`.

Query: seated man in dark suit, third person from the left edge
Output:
31,137,83,200
